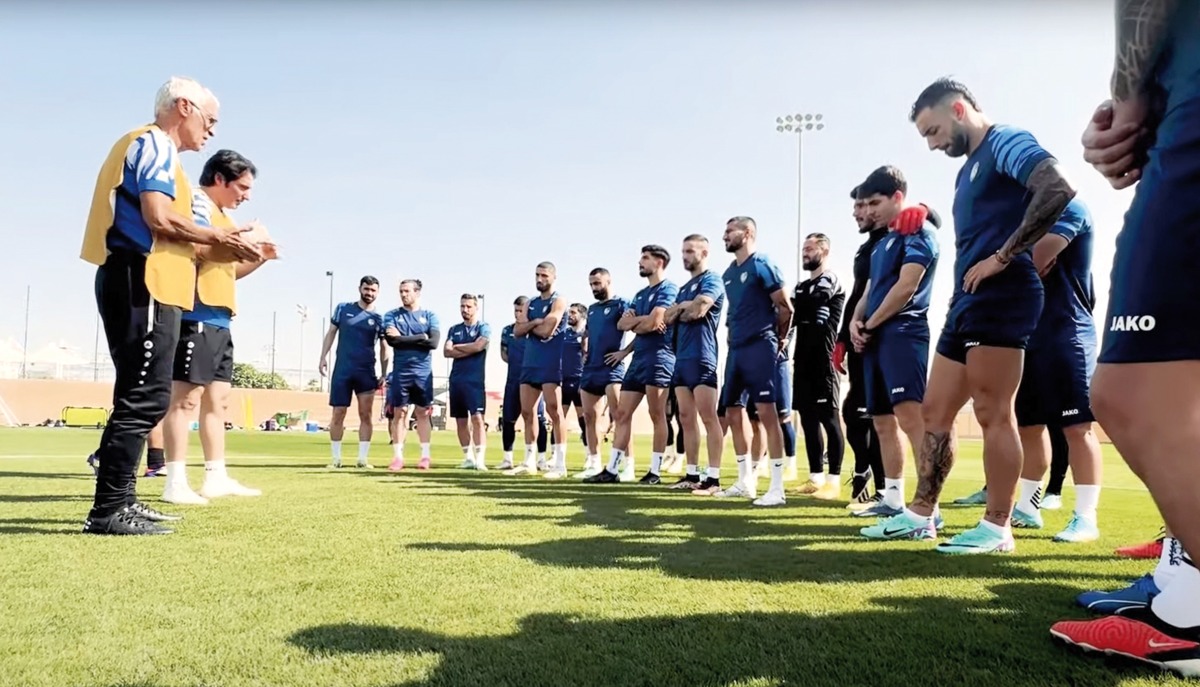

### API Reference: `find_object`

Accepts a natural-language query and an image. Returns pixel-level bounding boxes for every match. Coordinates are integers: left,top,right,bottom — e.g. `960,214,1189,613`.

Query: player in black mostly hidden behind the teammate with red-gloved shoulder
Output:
833,186,888,508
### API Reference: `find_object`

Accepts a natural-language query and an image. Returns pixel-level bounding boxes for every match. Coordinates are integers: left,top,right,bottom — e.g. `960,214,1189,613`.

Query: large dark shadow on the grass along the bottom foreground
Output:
289,584,1141,687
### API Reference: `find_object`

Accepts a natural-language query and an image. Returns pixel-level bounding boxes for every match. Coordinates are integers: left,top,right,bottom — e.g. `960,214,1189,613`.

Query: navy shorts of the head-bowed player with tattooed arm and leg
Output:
937,272,1045,364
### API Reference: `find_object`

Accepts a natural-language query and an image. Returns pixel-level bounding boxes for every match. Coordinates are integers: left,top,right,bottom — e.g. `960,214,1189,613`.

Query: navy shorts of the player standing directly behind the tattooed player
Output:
1016,331,1096,428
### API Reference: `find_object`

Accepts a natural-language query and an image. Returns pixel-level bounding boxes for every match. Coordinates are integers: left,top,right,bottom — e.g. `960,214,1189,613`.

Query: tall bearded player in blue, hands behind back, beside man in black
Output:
718,216,792,506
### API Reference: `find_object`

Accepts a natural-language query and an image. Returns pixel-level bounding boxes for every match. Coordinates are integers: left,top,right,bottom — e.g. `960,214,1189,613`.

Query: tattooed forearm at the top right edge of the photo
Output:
1111,0,1178,101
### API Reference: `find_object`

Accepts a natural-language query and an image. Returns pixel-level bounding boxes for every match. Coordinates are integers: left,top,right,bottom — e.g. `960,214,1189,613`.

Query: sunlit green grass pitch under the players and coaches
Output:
0,429,1176,687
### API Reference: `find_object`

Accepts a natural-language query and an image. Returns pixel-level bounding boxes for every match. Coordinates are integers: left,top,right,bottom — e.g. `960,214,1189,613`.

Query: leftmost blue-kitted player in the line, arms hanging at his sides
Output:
317,275,391,470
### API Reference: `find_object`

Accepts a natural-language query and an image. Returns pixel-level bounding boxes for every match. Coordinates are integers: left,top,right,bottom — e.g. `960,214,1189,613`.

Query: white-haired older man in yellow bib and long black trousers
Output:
80,77,262,534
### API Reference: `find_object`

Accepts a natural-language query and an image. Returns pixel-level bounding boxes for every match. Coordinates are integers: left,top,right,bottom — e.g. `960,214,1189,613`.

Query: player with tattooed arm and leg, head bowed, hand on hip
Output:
907,78,1075,554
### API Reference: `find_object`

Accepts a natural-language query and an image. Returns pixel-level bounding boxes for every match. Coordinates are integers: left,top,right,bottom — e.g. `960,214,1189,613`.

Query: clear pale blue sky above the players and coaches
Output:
0,0,1132,384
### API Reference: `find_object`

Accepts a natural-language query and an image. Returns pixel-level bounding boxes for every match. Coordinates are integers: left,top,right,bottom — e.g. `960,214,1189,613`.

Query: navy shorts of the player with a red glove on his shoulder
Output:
863,325,931,416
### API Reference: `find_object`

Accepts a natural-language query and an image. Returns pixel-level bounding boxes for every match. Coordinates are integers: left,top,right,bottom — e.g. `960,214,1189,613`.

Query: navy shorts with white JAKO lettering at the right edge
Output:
1099,97,1200,363
